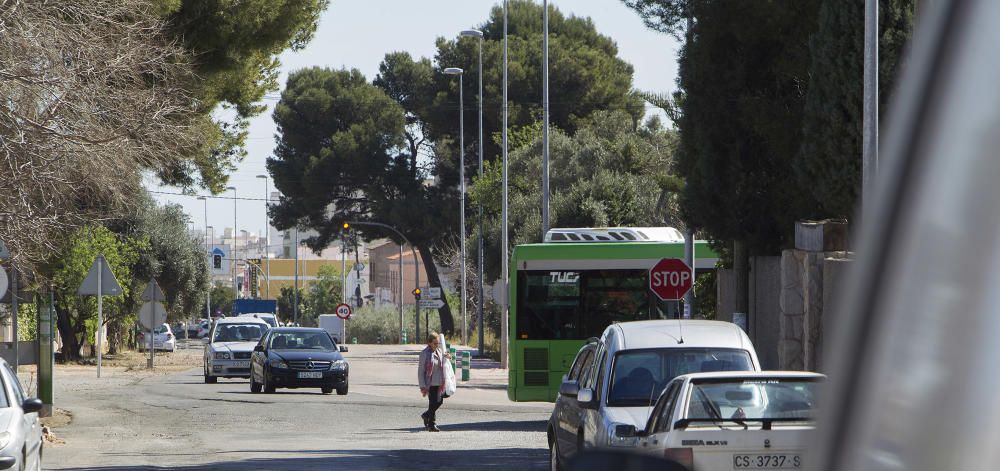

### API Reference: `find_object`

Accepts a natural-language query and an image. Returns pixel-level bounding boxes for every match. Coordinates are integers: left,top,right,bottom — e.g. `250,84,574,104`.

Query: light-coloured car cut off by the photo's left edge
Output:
0,359,42,470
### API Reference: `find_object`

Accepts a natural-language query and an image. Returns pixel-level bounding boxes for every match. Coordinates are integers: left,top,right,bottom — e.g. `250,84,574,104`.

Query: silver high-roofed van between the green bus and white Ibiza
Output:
548,320,761,468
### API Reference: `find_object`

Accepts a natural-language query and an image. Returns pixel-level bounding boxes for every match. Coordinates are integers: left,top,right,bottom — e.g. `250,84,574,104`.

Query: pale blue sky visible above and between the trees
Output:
148,0,680,233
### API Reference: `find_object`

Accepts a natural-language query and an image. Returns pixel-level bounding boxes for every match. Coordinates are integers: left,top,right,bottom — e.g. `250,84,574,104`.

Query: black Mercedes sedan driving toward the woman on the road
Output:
250,327,348,395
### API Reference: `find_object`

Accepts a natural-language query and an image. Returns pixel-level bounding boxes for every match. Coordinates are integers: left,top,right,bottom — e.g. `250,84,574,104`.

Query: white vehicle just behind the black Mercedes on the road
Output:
202,317,270,383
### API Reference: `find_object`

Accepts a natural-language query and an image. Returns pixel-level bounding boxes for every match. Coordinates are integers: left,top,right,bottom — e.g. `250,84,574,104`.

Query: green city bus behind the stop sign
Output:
507,228,718,402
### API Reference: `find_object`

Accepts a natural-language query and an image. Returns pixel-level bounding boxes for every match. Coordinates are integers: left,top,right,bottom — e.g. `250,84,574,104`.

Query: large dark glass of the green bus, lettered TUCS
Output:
515,270,667,340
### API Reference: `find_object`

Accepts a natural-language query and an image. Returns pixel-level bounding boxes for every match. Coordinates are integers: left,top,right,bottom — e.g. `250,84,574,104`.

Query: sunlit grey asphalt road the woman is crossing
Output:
44,345,551,470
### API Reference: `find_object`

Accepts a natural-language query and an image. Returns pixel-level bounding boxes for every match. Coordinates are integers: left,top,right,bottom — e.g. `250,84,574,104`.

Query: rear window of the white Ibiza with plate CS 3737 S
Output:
685,378,819,421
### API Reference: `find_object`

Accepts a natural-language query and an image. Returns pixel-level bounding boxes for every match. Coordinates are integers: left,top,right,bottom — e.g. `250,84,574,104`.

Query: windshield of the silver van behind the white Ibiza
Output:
608,348,753,407
